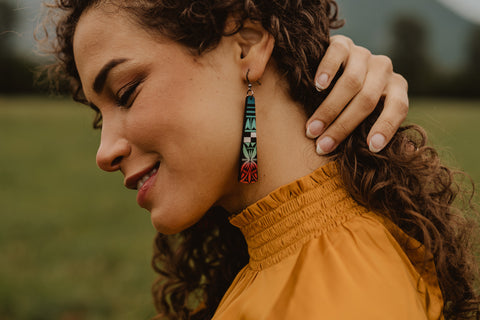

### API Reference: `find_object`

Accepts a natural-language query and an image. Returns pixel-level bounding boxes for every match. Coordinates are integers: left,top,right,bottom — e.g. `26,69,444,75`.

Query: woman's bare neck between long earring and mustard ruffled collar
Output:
224,68,328,213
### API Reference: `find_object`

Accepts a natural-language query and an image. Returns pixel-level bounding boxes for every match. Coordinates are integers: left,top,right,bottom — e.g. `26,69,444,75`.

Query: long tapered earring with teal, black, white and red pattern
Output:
238,70,258,183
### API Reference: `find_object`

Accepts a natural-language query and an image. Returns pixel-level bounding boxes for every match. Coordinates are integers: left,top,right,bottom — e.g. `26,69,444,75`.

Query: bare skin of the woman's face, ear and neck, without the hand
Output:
74,7,327,234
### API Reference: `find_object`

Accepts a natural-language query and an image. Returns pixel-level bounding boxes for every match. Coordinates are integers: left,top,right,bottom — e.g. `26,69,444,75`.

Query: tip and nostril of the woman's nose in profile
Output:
96,126,131,172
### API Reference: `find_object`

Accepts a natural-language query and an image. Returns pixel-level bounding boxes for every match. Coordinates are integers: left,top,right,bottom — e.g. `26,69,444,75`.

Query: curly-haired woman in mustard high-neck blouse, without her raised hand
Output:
43,0,478,319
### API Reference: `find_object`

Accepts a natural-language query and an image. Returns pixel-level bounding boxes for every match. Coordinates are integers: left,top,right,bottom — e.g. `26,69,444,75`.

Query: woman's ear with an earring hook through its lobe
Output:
234,19,275,82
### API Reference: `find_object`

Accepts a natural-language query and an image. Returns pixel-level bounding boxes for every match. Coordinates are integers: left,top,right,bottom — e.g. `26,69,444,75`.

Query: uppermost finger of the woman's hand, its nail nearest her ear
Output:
315,35,354,91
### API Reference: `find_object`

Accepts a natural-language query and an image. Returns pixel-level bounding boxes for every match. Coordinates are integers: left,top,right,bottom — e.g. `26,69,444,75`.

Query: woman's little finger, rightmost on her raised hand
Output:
367,73,409,152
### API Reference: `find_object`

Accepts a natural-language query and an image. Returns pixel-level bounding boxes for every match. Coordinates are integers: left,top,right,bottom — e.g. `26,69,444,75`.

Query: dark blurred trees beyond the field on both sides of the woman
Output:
0,1,480,98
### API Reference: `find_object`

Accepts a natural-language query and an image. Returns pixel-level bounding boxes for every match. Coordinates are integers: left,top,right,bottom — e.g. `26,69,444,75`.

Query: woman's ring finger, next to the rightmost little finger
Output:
317,56,392,155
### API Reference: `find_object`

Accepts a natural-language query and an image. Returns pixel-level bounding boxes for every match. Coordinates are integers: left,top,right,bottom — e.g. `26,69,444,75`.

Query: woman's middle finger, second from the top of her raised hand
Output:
307,42,372,141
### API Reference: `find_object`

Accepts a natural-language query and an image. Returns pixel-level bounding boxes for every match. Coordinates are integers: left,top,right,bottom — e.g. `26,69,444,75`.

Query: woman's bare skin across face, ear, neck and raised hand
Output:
74,3,408,233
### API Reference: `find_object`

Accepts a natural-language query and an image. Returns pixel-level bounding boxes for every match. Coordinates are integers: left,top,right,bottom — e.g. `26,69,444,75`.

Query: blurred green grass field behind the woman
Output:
0,97,480,320
